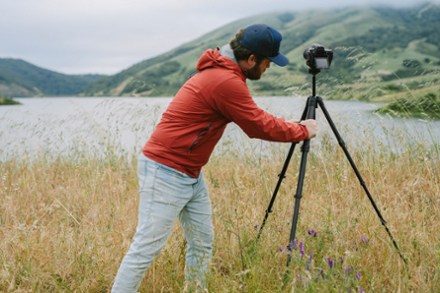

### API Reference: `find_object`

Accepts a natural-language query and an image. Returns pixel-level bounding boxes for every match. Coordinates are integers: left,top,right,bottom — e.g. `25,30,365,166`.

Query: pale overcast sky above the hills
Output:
0,0,440,74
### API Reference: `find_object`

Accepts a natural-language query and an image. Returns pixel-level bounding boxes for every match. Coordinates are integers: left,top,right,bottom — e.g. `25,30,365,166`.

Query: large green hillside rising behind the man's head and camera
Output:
86,4,440,100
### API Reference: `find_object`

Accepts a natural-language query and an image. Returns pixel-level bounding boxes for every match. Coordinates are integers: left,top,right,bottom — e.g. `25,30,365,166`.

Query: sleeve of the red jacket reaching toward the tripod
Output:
213,79,308,142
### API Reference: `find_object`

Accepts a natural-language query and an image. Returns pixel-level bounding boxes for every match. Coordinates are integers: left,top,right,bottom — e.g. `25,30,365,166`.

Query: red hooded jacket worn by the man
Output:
142,49,308,178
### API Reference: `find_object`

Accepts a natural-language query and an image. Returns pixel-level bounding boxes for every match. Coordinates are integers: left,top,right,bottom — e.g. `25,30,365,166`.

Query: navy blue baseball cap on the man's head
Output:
240,24,289,66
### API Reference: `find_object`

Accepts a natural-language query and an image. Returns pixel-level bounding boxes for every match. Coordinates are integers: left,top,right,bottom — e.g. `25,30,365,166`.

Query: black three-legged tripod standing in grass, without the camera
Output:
257,68,407,268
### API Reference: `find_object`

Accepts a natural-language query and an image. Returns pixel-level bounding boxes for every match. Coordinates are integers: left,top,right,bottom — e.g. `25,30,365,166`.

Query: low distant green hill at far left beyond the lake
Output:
0,58,102,97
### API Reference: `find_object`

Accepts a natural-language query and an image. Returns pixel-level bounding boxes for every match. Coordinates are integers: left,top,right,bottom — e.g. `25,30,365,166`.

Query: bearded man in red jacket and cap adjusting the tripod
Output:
112,24,317,292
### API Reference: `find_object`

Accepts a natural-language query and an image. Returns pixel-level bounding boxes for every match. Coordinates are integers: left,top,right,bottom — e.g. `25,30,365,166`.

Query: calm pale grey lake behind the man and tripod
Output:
0,97,440,161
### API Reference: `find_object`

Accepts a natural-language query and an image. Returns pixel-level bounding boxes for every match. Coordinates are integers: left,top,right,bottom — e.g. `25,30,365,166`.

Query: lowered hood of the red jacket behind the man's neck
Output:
196,48,246,80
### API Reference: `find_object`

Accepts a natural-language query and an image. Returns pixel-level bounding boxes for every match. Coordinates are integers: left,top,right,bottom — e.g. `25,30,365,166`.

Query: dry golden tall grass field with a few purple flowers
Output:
0,138,440,292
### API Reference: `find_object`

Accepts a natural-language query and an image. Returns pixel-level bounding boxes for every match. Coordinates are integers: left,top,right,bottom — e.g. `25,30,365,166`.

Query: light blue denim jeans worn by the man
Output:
112,154,214,293
